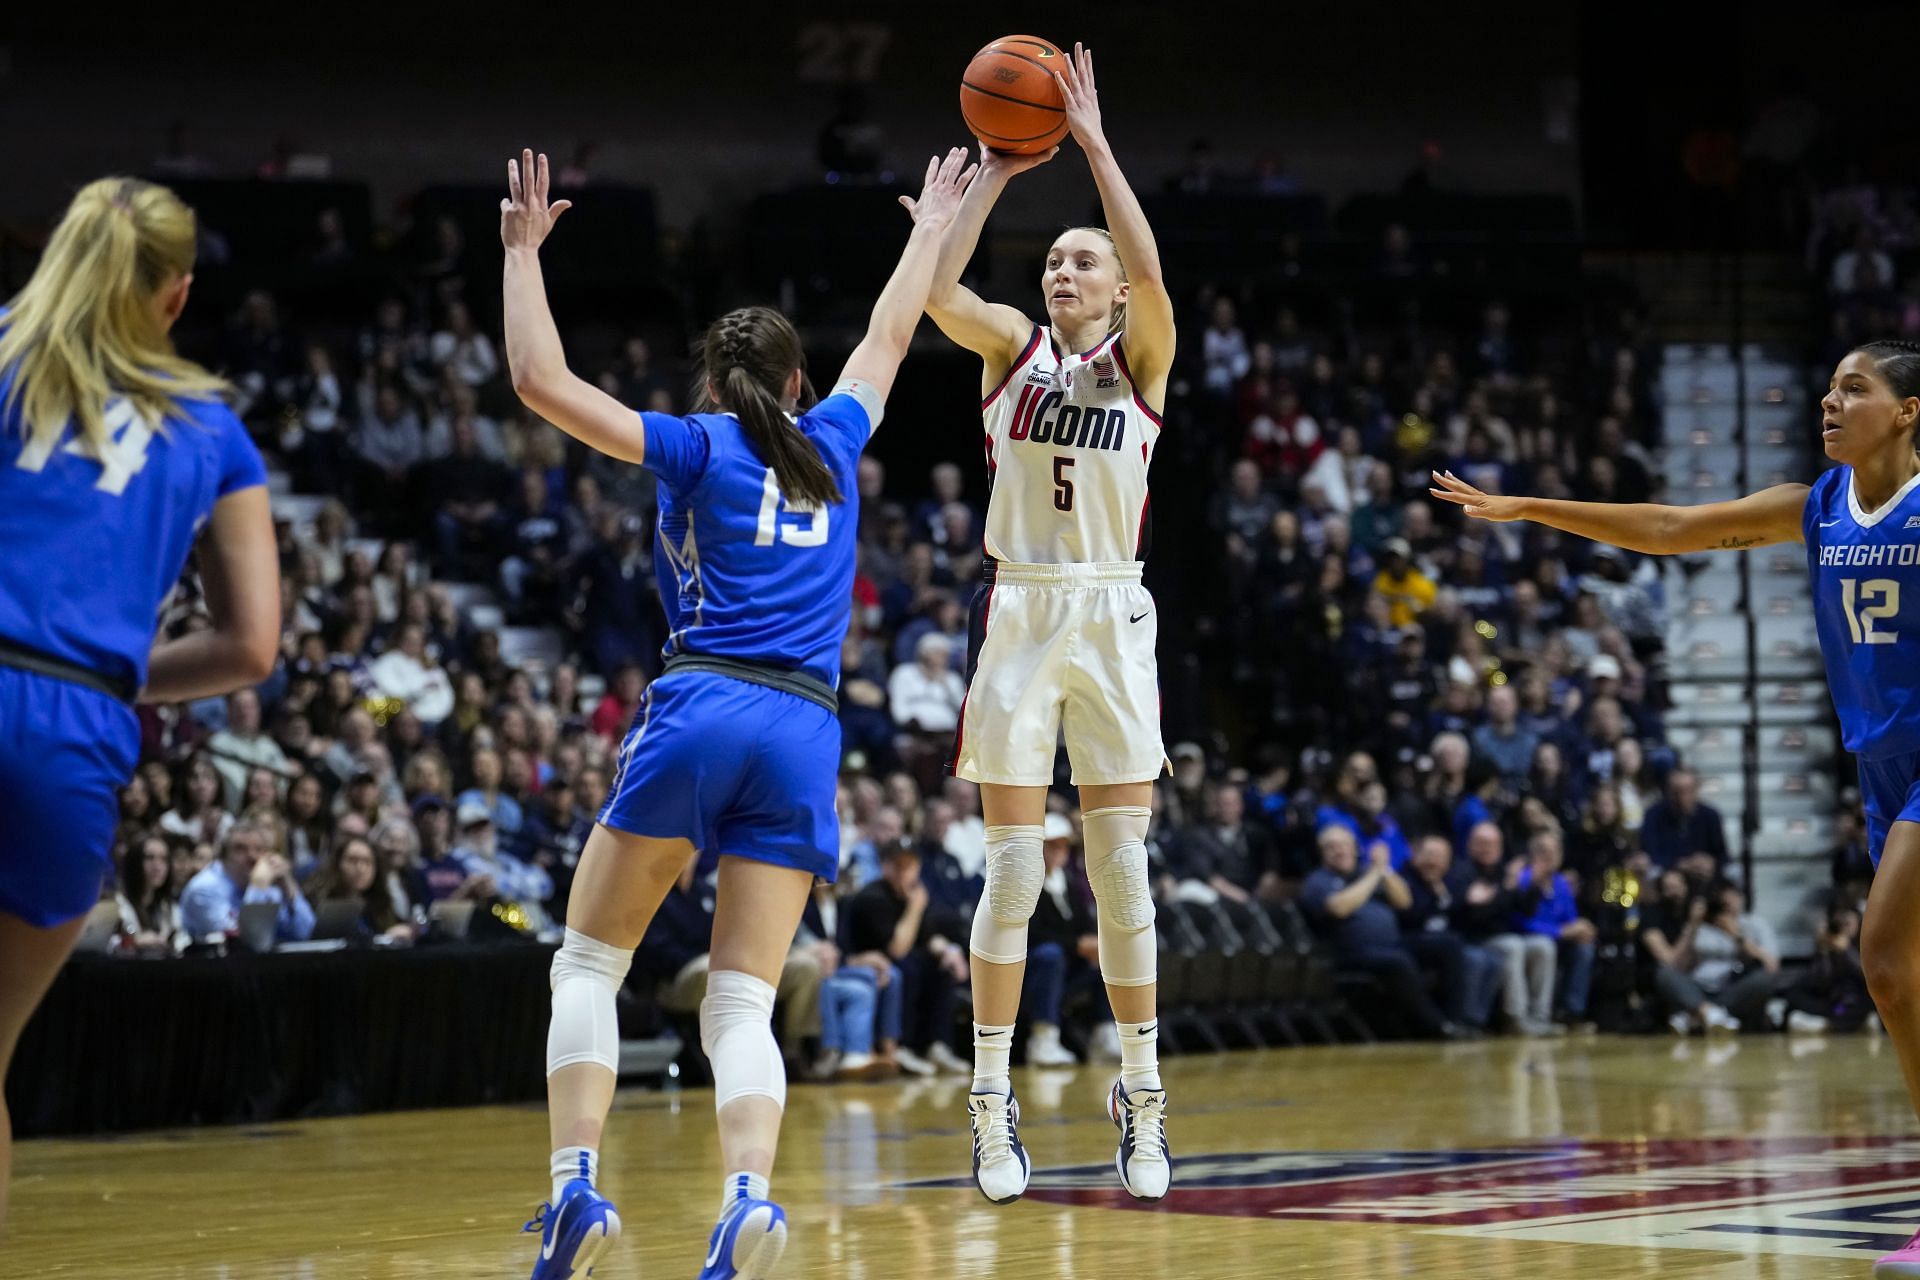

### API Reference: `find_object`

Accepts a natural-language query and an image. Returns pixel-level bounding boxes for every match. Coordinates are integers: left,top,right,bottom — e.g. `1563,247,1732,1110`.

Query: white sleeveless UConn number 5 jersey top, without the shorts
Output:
981,326,1160,564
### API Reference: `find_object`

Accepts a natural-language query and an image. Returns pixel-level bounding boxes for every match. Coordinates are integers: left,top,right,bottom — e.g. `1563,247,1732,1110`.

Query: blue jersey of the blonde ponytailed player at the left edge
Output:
0,347,267,685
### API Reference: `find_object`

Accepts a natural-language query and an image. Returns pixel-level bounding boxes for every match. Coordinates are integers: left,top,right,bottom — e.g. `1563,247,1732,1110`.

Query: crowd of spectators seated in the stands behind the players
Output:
78,172,1857,1079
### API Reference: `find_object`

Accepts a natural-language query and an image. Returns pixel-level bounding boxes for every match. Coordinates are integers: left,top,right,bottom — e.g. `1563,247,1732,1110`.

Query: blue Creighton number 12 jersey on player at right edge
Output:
1801,466,1920,760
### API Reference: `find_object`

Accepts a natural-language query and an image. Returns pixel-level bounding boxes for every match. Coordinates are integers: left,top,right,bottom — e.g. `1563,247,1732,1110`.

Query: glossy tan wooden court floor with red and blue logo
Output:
15,1036,1920,1280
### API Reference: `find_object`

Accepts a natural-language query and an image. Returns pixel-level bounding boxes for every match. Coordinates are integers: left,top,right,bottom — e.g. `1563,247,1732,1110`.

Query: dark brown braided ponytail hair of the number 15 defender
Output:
693,307,847,510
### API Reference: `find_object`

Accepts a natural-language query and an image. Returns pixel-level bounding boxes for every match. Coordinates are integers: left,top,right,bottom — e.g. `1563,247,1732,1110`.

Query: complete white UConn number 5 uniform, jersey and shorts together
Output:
950,326,1167,787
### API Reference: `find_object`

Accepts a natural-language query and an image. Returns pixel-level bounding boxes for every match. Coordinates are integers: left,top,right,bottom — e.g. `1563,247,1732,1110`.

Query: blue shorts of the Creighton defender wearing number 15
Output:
599,672,841,881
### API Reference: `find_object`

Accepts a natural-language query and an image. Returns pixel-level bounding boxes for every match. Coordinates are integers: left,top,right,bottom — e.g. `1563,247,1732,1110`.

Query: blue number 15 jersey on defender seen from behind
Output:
641,384,879,687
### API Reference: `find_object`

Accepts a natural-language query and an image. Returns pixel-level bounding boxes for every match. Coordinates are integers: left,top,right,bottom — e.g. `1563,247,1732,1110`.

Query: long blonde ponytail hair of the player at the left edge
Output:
0,178,228,457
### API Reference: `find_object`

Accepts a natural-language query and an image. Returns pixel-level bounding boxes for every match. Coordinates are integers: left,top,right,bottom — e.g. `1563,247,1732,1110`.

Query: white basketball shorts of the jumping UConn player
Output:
950,562,1169,787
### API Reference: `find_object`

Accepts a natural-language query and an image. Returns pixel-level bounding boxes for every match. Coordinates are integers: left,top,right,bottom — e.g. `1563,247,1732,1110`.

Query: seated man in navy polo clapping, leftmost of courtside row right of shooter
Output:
1300,825,1467,1040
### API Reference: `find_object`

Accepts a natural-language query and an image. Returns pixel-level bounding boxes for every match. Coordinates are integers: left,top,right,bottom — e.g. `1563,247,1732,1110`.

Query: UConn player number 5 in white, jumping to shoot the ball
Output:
908,40,1175,1203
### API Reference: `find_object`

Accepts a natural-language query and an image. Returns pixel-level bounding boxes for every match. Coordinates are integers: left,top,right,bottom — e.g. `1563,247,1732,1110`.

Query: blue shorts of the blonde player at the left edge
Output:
0,666,140,929
